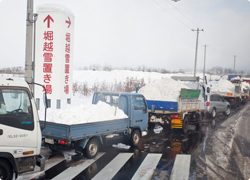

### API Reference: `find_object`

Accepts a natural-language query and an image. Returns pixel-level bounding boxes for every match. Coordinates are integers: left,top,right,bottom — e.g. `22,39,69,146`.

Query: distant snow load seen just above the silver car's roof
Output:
210,79,235,93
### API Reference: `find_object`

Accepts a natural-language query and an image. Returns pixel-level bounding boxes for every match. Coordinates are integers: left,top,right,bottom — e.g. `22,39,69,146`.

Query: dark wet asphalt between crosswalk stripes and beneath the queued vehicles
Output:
30,106,244,180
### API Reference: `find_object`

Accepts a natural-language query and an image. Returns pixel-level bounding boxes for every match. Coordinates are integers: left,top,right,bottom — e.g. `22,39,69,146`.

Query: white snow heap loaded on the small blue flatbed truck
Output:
43,101,128,125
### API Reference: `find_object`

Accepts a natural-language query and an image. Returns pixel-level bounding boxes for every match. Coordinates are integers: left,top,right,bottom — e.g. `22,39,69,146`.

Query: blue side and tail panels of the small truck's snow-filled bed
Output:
40,118,129,141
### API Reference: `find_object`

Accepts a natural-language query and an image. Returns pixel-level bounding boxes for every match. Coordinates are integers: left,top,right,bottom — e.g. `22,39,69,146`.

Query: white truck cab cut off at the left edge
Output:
0,78,47,180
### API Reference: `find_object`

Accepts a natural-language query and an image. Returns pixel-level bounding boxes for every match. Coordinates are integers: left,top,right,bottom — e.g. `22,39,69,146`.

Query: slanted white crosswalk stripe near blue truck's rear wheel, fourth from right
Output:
53,153,105,180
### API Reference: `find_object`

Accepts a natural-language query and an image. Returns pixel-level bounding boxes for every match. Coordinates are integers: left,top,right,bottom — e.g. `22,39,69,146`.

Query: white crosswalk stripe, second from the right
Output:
132,154,162,180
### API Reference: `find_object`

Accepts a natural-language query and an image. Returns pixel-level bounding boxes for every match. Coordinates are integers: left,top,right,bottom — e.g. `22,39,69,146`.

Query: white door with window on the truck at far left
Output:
0,88,38,157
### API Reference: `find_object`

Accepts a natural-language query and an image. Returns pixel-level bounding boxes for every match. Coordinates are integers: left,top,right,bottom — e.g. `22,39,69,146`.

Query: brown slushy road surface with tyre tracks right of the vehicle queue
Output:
194,103,250,180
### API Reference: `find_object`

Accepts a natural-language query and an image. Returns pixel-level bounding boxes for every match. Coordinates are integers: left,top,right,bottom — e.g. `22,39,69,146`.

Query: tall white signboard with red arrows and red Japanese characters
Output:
35,5,74,99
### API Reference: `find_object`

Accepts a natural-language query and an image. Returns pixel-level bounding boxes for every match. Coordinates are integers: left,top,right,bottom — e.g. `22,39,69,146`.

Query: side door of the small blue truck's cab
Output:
131,96,148,130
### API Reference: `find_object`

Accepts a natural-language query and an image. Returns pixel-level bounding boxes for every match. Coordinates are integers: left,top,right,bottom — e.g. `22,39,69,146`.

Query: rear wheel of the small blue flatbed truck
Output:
85,138,99,159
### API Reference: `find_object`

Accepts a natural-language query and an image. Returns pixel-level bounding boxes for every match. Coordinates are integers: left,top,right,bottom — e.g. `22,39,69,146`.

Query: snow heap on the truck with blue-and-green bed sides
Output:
139,78,190,101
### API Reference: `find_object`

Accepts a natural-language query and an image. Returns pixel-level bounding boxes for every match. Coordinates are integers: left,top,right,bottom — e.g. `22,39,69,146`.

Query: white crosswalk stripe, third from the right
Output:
92,153,134,180
